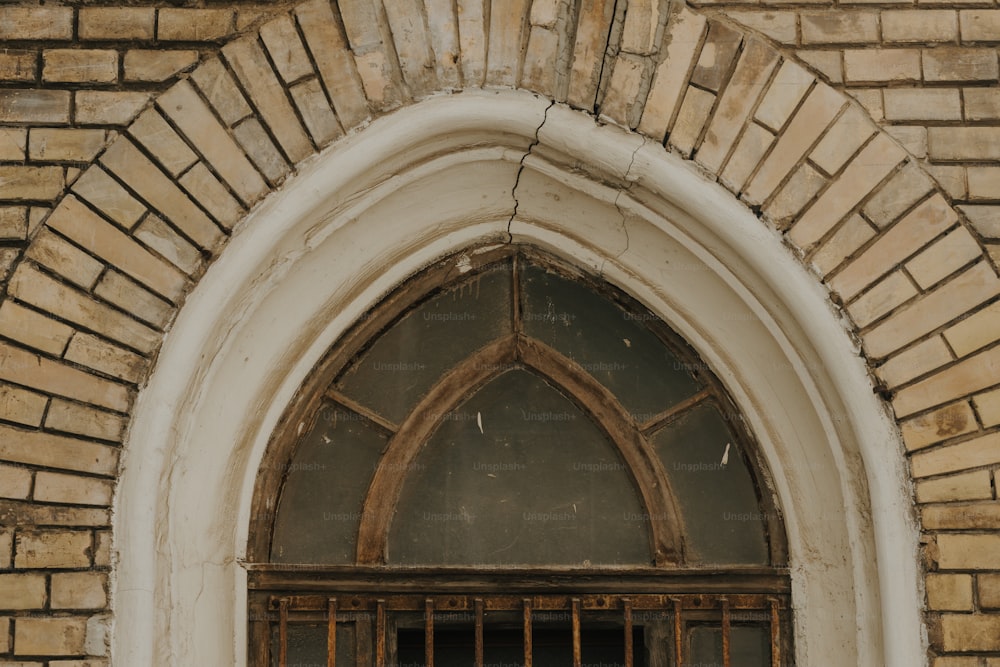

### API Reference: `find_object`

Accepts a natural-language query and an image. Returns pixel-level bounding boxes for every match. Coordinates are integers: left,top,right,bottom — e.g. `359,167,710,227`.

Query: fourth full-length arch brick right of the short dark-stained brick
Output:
828,192,958,299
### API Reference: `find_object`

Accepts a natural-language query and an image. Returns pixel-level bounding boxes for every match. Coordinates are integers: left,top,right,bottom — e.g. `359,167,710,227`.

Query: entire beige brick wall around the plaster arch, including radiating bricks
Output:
0,0,1000,667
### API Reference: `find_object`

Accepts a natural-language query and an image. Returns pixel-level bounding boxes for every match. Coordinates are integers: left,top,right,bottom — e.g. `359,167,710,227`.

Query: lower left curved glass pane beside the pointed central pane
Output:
271,403,388,564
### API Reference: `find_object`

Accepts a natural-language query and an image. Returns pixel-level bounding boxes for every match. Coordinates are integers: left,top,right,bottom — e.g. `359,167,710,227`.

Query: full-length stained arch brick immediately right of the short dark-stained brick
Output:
695,39,777,173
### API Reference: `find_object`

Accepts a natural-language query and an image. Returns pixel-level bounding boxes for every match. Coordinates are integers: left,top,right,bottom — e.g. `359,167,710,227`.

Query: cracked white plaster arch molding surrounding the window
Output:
112,91,926,667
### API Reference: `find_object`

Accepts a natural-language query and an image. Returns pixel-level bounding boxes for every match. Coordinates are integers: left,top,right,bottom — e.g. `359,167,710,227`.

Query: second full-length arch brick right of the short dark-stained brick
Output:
744,86,845,204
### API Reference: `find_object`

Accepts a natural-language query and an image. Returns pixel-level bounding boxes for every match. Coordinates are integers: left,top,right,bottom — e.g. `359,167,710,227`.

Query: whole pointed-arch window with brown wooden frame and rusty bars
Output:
248,245,792,667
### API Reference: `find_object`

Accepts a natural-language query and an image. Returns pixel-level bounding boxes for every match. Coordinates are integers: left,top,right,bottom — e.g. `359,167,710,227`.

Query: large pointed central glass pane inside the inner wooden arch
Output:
389,370,651,565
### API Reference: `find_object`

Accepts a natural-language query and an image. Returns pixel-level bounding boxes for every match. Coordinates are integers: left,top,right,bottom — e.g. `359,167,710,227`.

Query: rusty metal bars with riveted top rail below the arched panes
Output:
264,594,790,667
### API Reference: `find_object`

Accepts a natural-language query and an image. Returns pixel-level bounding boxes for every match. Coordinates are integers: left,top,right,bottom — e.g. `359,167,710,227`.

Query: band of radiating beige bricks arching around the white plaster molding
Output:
0,0,1000,667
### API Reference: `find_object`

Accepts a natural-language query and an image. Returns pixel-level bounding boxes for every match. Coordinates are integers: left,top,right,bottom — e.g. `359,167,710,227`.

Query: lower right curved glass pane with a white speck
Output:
653,403,768,564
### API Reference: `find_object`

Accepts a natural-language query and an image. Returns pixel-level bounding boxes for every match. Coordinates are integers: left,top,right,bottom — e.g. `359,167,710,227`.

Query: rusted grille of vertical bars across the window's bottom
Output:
256,593,790,667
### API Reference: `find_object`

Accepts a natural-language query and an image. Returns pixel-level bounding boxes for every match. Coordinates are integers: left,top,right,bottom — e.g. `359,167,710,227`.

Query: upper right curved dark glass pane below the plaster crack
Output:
522,266,700,423
